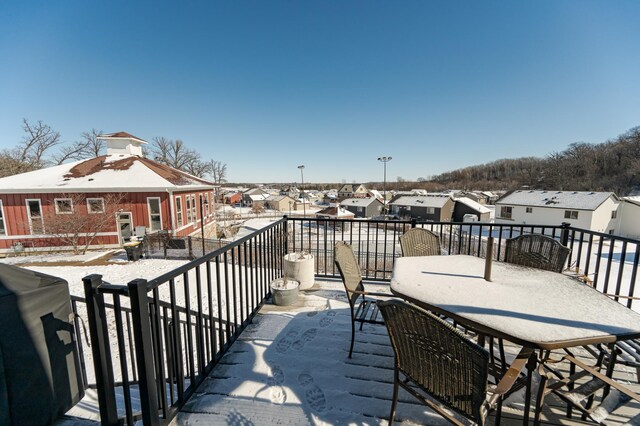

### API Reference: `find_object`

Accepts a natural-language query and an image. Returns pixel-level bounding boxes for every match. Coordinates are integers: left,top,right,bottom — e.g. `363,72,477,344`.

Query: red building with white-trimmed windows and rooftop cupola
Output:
0,132,214,253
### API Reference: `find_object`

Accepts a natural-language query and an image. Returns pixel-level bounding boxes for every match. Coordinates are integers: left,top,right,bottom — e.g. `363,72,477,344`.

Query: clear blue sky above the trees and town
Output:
0,0,640,182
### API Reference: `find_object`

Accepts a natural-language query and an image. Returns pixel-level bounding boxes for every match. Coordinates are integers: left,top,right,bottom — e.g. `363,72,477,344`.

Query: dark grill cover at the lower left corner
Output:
0,264,84,425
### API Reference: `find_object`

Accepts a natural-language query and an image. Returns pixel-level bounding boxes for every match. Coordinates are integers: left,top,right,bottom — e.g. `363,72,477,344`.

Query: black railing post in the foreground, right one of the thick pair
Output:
127,279,160,426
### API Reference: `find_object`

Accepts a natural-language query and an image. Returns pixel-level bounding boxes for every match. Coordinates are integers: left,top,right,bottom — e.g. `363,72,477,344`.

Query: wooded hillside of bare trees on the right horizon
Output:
424,127,640,195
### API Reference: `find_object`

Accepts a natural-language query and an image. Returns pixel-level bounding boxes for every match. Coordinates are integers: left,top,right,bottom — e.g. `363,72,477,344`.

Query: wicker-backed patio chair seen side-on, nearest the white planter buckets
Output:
334,241,391,358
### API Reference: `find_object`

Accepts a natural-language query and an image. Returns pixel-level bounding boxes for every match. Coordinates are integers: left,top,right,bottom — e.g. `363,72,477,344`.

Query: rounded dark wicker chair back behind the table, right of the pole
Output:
505,234,571,272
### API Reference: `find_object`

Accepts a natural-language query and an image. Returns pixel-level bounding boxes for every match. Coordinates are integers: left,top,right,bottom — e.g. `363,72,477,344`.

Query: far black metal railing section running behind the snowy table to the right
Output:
287,218,640,308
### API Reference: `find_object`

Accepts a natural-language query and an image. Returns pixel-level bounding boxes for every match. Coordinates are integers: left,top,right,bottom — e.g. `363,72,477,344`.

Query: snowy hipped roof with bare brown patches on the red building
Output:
0,154,214,193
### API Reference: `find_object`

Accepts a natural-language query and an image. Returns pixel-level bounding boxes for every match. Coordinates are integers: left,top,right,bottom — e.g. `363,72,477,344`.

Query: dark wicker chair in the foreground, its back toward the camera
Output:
378,300,508,425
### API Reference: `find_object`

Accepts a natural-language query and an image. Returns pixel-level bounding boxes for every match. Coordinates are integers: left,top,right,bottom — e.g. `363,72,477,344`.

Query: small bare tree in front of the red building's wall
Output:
43,193,124,254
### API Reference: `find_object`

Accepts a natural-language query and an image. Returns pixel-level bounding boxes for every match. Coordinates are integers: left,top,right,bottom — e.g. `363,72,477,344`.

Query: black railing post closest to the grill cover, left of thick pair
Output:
82,274,118,425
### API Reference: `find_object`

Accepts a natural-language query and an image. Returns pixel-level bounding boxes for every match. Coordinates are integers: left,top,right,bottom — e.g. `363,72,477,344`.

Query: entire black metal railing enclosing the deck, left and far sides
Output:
74,217,640,424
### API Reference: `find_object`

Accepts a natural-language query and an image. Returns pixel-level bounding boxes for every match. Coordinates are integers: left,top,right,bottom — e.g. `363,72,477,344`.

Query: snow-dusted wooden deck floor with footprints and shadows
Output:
172,281,640,425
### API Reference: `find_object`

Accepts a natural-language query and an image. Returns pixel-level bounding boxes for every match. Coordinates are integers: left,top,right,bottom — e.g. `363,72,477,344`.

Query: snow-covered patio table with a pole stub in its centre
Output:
391,255,640,424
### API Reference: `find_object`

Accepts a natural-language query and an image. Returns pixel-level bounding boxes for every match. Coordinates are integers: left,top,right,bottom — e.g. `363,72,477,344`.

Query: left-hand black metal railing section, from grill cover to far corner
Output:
81,220,287,424
